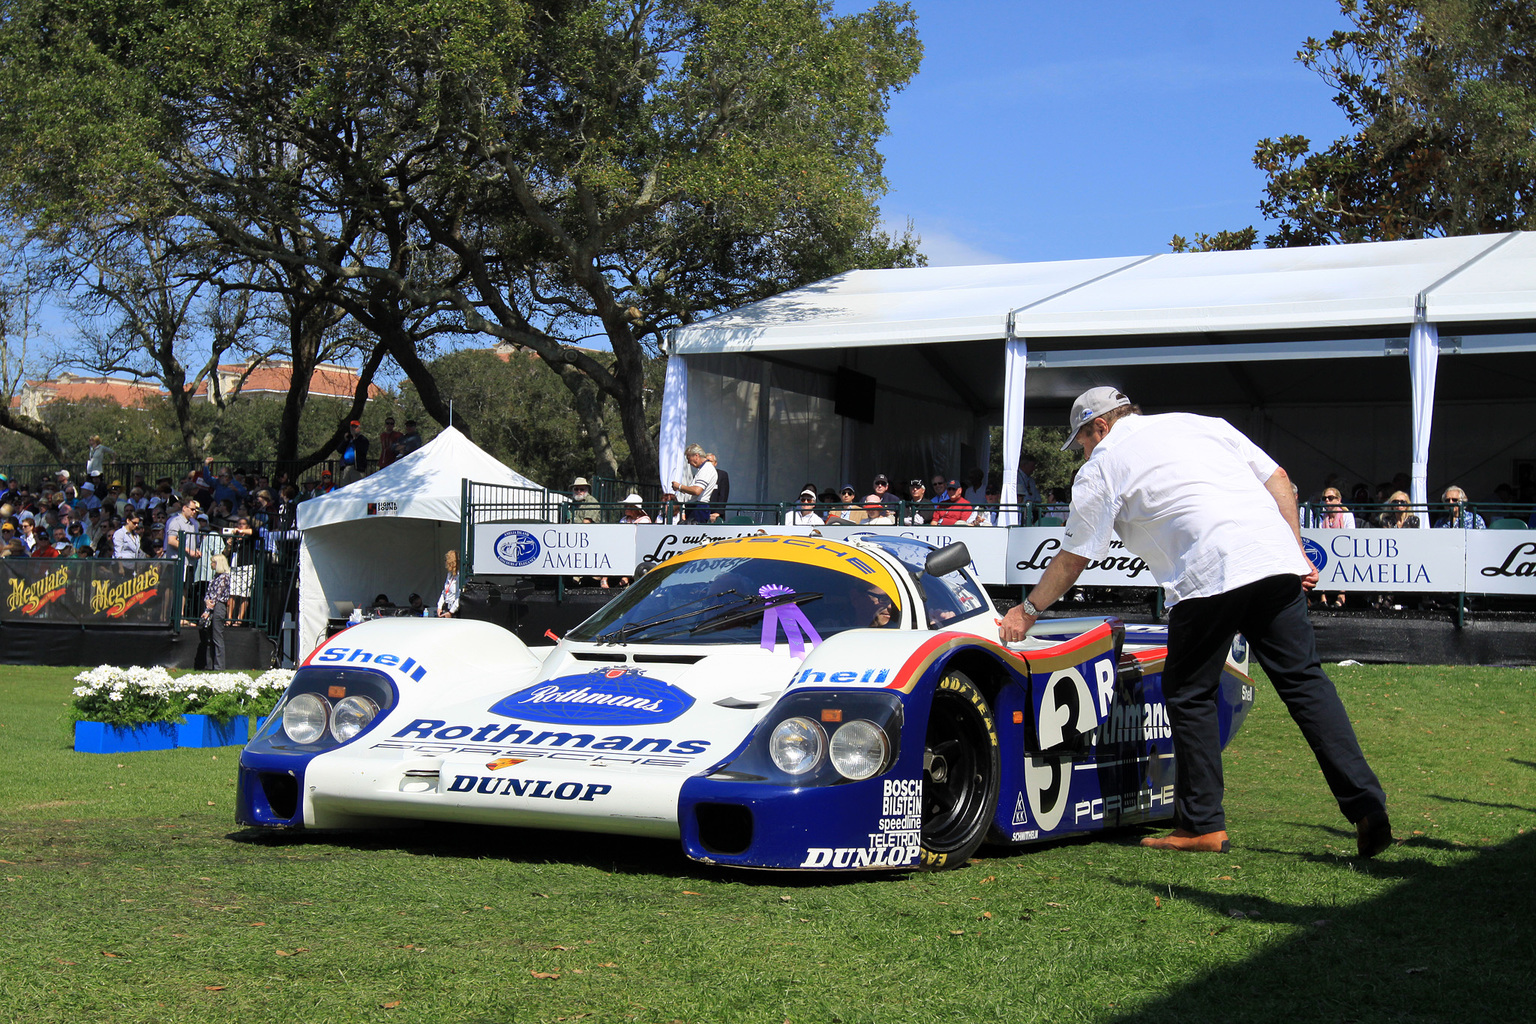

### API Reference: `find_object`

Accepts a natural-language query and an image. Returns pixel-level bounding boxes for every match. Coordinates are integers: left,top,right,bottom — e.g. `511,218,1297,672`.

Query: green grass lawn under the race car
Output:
0,666,1536,1024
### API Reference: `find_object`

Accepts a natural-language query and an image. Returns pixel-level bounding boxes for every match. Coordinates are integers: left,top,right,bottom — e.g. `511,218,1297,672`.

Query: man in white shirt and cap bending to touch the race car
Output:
1000,387,1392,857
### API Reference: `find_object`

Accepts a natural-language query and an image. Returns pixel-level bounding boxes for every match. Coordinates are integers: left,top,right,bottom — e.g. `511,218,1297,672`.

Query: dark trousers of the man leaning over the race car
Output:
1163,576,1387,834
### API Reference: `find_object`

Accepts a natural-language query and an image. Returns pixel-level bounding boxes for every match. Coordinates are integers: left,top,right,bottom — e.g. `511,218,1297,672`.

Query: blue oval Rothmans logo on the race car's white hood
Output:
492,668,693,725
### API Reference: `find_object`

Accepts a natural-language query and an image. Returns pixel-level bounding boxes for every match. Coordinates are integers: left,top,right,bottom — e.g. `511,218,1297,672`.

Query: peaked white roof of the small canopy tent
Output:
298,427,544,530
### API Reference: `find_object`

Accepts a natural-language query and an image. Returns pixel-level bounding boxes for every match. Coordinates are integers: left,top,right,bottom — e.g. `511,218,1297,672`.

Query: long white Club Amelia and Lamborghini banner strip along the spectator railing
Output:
472,524,1536,594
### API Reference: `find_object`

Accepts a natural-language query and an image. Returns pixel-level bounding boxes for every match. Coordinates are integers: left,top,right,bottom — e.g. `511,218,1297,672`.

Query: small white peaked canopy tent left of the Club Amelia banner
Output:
298,427,544,660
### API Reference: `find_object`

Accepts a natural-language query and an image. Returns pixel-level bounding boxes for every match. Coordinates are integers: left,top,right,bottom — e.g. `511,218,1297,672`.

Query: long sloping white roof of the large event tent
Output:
673,232,1536,355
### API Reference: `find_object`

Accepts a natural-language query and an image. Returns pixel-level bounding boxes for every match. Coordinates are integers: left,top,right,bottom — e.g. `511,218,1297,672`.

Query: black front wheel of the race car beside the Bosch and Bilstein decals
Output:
922,671,1001,870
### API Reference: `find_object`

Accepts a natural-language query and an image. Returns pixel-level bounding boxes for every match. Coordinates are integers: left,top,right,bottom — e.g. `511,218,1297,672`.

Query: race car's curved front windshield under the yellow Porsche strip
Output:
570,553,902,645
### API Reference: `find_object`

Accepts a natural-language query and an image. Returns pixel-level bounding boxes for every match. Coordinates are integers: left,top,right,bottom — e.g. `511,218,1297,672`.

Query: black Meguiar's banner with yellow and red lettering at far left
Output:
0,559,175,626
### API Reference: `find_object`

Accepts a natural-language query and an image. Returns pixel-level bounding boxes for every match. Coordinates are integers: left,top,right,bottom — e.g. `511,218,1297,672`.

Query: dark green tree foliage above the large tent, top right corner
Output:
1253,0,1536,246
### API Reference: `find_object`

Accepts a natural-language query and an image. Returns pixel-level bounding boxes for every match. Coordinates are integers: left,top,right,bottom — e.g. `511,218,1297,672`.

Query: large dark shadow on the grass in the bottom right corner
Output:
1117,834,1536,1024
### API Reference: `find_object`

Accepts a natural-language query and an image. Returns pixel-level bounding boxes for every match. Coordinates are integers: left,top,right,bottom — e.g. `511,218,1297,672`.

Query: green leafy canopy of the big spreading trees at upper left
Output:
0,0,922,476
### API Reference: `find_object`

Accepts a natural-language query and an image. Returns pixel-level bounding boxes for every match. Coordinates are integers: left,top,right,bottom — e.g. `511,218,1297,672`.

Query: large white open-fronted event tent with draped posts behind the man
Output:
659,232,1536,521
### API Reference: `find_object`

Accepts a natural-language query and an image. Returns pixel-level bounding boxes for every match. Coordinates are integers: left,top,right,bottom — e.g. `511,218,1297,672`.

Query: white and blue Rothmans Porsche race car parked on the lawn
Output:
237,534,1253,870
